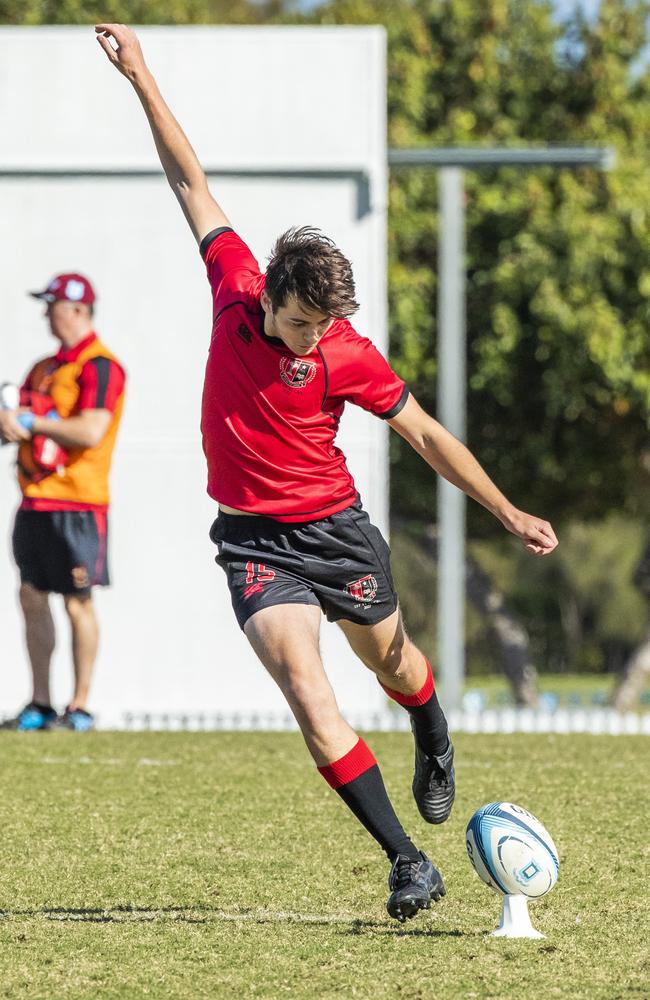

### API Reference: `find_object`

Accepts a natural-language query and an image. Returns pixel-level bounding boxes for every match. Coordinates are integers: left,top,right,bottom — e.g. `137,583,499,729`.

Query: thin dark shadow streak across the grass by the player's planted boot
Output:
0,905,482,938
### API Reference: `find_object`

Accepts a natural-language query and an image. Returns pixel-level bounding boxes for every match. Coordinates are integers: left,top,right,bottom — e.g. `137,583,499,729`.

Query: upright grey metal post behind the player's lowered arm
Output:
438,167,466,709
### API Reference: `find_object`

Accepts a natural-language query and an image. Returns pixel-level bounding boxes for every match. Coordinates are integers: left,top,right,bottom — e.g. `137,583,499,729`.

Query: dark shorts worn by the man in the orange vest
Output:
13,510,109,596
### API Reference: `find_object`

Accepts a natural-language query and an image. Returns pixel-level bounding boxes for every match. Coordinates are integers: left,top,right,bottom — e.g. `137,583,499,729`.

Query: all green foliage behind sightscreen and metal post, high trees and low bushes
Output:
5,0,650,672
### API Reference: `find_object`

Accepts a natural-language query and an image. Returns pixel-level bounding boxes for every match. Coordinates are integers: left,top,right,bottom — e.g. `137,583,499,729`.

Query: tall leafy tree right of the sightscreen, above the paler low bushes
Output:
302,0,650,532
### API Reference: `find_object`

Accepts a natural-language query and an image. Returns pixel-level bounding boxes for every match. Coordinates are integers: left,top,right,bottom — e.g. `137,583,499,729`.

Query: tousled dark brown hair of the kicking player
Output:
266,226,359,319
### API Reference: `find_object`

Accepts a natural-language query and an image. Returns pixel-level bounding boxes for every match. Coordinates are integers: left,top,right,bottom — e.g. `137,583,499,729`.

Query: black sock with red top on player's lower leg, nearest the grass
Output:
318,739,420,861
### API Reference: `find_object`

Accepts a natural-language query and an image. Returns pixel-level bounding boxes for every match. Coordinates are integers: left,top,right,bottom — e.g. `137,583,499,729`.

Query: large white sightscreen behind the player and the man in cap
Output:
0,28,387,724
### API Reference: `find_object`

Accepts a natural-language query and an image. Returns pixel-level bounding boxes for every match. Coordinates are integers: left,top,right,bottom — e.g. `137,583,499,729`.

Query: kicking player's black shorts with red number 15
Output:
210,502,397,629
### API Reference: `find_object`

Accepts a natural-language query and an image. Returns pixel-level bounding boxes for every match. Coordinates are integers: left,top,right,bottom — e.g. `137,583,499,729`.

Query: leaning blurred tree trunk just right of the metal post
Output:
418,527,539,708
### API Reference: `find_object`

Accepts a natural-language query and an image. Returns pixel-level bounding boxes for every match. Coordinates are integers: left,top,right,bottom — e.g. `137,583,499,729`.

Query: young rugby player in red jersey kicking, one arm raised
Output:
95,24,557,920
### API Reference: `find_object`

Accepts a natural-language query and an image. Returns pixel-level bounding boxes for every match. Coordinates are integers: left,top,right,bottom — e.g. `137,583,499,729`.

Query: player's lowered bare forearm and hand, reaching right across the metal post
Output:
388,396,557,556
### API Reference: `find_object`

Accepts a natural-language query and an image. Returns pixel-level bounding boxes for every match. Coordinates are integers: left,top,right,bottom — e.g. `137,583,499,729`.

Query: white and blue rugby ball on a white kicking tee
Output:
465,802,560,899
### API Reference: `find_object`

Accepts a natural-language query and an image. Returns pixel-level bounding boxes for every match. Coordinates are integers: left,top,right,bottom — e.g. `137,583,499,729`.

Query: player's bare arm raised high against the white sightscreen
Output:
95,24,229,243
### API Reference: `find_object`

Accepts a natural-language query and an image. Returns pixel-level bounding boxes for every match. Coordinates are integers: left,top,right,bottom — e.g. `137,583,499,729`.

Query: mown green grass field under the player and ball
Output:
0,732,650,1000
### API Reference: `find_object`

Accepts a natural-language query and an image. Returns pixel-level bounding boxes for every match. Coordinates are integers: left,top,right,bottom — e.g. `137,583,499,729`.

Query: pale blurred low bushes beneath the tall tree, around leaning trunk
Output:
391,515,648,676
